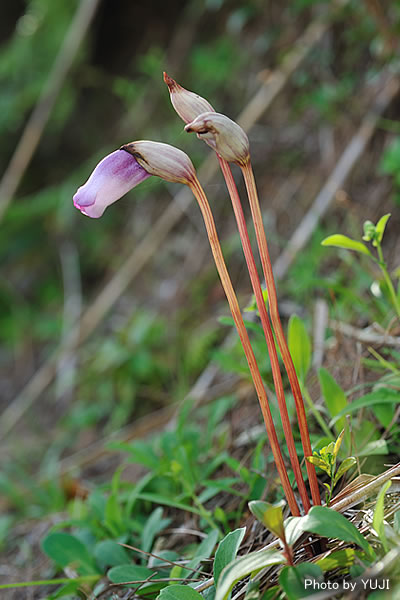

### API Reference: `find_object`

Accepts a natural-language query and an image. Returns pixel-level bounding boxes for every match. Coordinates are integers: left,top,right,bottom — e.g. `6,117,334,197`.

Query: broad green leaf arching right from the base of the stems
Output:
301,506,375,558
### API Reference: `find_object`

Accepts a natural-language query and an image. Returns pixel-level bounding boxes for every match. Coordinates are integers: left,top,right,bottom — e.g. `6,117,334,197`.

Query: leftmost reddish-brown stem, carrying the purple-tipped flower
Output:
190,178,300,516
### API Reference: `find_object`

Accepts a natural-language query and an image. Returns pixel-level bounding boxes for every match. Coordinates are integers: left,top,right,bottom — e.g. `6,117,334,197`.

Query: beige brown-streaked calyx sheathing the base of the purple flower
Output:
122,141,196,185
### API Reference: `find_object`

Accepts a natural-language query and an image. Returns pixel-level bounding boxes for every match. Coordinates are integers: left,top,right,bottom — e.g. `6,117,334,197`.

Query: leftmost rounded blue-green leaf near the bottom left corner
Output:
41,533,99,575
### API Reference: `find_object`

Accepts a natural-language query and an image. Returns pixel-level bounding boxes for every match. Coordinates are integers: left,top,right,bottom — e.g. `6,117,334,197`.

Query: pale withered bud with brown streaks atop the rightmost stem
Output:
185,112,250,166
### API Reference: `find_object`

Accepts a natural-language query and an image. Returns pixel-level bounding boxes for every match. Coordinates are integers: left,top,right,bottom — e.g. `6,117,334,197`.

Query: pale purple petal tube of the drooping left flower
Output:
73,150,150,219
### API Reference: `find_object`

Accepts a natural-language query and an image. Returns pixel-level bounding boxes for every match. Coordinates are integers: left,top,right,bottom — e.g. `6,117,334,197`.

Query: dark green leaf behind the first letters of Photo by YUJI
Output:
279,562,324,600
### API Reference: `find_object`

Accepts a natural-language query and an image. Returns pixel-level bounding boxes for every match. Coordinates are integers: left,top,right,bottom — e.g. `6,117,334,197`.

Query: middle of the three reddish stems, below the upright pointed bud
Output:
217,154,311,513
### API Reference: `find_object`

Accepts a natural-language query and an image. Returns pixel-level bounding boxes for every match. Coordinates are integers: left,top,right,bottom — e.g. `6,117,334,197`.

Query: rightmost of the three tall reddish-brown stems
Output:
241,160,321,504
